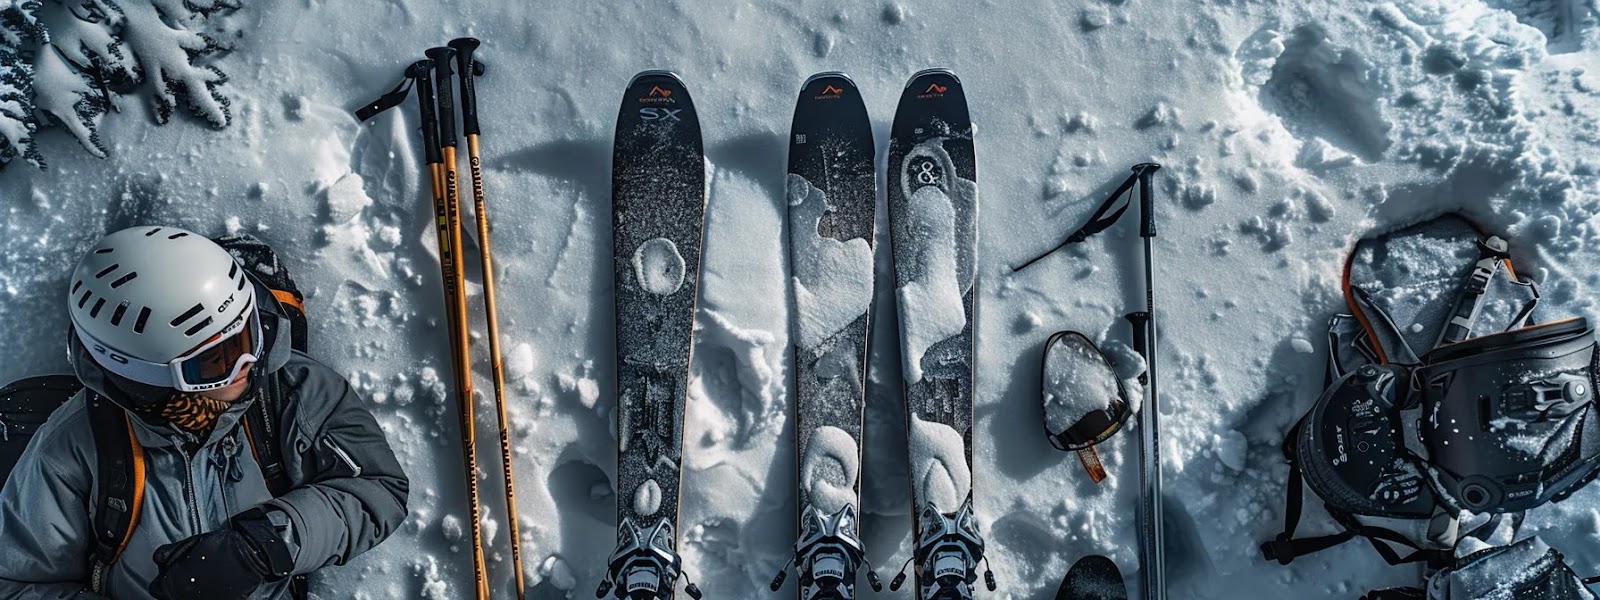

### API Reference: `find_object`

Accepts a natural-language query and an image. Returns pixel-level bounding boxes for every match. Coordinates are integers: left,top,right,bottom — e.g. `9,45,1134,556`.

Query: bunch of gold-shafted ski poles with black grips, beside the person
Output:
357,37,525,600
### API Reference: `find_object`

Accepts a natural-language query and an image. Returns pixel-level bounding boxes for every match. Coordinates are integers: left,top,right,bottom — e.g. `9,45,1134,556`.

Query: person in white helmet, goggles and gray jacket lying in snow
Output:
0,226,410,600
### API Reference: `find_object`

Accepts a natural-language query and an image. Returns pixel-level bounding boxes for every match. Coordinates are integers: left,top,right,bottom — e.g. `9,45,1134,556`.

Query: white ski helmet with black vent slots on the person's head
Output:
67,226,256,371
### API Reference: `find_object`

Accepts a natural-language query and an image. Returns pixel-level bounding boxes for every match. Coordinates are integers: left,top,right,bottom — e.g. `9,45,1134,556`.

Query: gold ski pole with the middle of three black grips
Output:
424,48,490,600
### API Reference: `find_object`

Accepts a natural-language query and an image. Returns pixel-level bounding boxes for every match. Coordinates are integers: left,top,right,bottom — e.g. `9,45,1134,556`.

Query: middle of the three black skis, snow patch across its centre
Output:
771,72,883,600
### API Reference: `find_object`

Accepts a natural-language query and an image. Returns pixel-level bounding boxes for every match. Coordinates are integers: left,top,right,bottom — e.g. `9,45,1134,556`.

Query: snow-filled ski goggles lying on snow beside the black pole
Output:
1042,331,1130,483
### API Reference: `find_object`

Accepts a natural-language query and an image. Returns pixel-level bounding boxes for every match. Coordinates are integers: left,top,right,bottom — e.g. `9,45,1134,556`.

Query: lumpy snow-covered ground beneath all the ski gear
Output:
0,0,1600,598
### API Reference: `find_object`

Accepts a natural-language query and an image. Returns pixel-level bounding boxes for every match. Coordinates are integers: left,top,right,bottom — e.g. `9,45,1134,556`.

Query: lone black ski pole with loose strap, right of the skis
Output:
1011,163,1166,600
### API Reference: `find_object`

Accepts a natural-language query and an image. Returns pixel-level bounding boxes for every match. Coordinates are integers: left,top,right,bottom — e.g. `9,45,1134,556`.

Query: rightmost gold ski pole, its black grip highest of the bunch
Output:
450,37,526,598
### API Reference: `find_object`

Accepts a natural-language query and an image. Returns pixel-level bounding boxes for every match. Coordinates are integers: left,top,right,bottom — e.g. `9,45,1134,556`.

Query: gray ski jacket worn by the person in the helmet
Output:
0,294,410,600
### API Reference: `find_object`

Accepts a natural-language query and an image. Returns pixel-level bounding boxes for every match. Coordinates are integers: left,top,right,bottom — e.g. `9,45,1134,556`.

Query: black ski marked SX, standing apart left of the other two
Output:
595,70,706,600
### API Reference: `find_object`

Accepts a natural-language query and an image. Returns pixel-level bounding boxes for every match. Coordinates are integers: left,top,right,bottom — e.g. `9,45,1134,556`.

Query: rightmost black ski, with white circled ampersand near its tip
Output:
888,69,995,598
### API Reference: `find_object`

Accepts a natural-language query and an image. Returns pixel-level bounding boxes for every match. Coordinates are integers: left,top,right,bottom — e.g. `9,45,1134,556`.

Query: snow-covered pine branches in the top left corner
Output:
0,0,240,168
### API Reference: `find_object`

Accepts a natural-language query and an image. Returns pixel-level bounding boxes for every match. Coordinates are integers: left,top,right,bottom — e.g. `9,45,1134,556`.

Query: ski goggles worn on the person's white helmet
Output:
75,309,264,392
